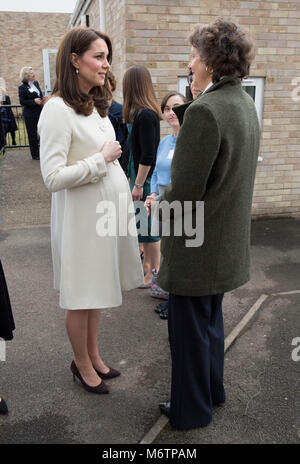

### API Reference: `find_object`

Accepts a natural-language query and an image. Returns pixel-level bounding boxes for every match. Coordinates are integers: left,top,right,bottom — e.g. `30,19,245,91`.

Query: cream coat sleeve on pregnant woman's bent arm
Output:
38,100,107,192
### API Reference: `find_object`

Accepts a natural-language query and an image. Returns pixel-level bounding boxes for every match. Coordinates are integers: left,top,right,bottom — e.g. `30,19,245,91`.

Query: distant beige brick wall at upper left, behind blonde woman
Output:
0,12,70,104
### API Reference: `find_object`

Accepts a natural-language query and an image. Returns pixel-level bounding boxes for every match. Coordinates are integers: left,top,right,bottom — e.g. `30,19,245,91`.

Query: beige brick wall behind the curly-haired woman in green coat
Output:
71,0,300,216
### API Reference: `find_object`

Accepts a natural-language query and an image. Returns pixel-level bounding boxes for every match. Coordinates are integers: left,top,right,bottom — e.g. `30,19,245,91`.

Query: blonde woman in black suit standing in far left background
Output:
19,66,44,160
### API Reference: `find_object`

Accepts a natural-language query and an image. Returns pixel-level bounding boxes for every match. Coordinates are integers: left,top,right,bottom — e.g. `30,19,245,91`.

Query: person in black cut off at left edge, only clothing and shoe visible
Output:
0,260,15,414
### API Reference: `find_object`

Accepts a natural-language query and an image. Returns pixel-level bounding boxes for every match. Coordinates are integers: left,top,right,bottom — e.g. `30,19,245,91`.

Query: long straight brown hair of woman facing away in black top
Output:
123,65,162,123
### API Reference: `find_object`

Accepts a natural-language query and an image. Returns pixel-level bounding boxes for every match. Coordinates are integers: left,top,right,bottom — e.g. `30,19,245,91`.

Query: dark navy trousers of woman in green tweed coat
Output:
168,294,225,429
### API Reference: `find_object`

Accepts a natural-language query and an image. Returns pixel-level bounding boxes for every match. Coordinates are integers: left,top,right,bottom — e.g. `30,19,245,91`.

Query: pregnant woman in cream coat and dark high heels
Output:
38,28,143,393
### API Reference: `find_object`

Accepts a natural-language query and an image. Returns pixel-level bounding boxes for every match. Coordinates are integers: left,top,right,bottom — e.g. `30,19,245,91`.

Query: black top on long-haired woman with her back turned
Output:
132,108,160,178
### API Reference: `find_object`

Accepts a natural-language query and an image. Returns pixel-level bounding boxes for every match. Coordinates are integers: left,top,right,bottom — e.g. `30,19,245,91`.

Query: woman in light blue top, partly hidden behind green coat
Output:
145,92,186,319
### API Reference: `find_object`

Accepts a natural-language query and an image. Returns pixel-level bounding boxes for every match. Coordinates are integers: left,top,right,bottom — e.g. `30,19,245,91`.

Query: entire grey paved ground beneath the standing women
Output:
0,150,300,444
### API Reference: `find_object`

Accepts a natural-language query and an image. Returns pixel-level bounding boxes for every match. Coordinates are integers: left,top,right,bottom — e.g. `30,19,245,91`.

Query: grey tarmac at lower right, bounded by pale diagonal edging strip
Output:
154,294,300,445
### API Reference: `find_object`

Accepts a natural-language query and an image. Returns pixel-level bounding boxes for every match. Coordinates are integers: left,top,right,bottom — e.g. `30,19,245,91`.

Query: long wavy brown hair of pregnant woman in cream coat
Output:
52,27,112,117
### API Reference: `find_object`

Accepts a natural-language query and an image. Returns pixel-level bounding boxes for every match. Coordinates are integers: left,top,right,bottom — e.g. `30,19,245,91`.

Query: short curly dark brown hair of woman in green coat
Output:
189,19,254,82
